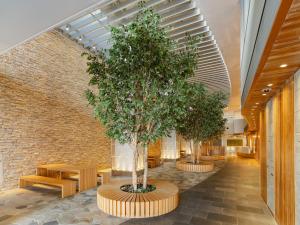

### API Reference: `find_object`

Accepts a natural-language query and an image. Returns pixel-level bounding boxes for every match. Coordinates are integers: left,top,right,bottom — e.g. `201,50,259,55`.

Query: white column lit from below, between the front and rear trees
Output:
161,130,180,159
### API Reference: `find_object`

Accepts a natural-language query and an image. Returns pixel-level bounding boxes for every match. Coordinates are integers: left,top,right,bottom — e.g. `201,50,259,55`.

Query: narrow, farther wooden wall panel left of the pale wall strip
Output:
258,110,267,202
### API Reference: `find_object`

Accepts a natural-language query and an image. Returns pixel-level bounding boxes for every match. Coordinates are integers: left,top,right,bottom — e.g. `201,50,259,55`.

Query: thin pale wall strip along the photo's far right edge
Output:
294,70,300,225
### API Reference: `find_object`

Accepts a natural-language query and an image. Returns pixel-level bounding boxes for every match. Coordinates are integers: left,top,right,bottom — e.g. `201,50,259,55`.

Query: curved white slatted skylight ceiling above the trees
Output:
60,0,230,93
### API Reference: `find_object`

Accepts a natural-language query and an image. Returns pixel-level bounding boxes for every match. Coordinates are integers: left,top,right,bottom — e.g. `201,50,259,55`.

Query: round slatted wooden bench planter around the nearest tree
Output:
97,180,179,218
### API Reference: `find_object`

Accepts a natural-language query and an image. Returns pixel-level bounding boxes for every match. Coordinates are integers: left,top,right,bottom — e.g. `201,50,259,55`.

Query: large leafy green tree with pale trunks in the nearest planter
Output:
86,9,200,190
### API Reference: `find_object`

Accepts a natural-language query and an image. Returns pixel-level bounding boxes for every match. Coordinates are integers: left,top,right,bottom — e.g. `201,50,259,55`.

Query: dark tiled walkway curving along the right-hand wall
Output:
123,158,276,225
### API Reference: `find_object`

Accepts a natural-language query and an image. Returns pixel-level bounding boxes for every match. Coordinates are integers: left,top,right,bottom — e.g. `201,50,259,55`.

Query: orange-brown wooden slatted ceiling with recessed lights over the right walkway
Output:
243,0,300,130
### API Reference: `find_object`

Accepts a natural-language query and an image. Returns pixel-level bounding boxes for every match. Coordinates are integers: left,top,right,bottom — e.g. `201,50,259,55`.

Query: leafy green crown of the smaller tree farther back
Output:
177,84,226,142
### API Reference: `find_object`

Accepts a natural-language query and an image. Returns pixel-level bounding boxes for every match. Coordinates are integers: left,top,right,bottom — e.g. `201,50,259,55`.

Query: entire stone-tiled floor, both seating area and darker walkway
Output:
0,159,275,225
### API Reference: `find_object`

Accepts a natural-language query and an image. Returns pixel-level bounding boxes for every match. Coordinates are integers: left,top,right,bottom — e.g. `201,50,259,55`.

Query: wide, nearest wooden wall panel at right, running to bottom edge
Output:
275,80,295,225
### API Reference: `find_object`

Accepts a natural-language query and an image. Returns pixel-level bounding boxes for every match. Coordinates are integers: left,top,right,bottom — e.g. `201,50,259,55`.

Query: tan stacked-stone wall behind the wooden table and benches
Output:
0,31,111,190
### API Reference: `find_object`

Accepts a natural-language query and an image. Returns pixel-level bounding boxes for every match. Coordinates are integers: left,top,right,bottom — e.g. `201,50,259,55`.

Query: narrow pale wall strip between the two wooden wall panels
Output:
266,99,275,214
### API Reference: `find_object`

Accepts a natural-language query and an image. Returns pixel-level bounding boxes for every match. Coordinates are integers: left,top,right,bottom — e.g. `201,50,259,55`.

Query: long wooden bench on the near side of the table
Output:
19,175,76,198
